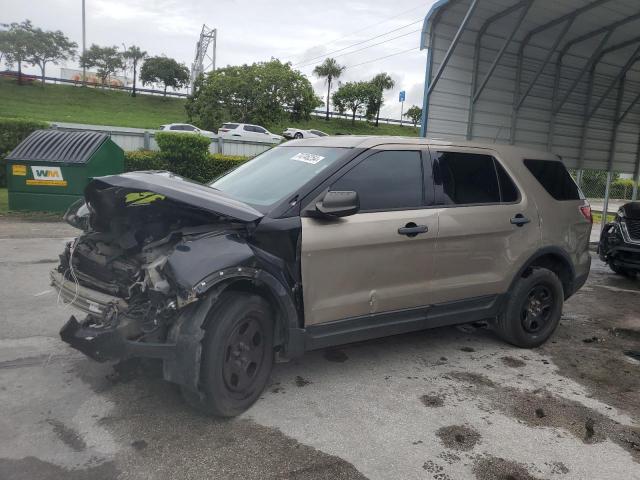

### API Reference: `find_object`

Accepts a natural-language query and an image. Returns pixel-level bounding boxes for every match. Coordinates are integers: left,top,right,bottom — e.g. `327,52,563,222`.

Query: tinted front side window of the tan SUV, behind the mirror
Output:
331,151,423,211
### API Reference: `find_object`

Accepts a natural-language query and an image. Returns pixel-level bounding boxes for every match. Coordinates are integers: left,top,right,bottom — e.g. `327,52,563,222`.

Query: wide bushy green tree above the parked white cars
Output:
187,59,322,129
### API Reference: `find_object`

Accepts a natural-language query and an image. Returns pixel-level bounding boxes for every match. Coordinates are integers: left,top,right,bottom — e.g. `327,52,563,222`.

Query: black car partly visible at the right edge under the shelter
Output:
598,202,640,276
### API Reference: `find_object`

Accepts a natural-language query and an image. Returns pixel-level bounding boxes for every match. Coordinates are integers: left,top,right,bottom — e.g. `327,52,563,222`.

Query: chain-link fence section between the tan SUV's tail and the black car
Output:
571,169,638,226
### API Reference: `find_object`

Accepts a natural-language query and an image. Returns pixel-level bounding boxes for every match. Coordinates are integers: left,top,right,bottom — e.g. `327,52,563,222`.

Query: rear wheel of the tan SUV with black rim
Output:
496,267,564,348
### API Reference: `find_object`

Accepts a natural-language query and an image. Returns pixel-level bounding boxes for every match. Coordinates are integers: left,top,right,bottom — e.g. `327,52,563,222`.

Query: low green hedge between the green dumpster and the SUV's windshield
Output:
124,150,247,183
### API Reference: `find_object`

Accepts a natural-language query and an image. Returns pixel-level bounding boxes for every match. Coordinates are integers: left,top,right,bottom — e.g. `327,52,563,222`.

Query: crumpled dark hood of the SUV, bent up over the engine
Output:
85,171,264,223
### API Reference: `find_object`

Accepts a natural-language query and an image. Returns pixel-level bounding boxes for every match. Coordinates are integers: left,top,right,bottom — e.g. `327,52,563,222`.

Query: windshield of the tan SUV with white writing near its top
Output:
210,147,347,206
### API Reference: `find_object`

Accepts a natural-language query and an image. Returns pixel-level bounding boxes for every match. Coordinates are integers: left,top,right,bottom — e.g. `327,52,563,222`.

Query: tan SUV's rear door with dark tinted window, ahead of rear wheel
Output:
431,147,540,304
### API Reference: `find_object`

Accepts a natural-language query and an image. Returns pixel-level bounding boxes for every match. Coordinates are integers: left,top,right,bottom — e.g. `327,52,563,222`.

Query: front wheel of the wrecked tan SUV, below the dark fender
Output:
183,292,273,417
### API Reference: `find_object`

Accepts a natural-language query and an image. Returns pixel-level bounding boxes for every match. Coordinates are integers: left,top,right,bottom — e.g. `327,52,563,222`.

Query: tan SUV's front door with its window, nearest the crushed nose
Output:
301,145,438,325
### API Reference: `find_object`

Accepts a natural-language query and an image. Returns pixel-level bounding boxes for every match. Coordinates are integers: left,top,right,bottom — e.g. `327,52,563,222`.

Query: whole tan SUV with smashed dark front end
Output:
51,136,591,416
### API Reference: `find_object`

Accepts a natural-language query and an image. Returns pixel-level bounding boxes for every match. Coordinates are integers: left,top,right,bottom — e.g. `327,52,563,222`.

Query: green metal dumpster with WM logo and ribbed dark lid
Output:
6,130,124,212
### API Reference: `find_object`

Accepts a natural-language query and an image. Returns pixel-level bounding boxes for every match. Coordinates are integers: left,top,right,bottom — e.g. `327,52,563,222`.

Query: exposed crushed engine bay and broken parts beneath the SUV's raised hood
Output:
52,211,226,346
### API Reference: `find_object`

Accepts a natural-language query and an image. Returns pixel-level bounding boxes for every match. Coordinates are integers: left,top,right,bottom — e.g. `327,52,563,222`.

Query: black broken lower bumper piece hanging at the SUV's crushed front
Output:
60,316,176,362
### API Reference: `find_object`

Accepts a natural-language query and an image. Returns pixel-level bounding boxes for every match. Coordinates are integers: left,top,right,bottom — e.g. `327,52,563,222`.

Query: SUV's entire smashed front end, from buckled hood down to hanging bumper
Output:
51,172,278,361
